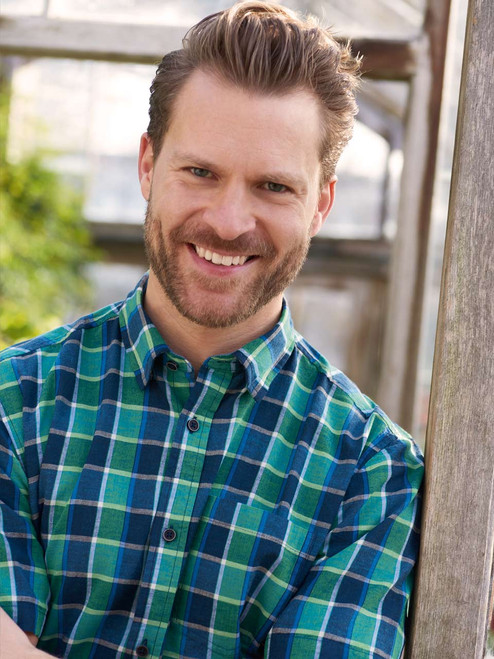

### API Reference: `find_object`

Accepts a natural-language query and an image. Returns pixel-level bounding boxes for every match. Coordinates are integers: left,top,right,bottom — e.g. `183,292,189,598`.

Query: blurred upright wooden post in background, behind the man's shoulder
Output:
376,0,450,431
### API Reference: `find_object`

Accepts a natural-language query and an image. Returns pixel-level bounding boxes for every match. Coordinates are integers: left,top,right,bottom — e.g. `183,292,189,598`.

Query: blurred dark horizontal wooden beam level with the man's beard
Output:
89,222,391,281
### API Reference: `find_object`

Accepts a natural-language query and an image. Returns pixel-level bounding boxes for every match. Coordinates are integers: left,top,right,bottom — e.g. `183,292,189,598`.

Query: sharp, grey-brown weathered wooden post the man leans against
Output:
407,0,494,659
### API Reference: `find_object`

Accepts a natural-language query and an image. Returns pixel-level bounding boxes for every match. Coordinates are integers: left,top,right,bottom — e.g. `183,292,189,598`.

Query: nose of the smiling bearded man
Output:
203,185,256,240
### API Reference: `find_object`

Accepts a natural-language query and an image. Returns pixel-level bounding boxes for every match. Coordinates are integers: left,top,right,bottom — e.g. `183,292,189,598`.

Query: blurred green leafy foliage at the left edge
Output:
0,96,95,348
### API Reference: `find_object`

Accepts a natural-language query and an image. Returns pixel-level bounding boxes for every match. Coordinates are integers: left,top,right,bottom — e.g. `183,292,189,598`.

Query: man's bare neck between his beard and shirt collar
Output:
144,278,282,374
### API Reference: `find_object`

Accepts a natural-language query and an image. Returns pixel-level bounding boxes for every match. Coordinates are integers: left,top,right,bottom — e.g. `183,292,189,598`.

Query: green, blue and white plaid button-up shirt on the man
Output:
0,279,423,659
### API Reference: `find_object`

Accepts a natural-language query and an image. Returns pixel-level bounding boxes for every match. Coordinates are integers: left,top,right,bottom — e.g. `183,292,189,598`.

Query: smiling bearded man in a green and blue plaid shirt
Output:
0,2,422,659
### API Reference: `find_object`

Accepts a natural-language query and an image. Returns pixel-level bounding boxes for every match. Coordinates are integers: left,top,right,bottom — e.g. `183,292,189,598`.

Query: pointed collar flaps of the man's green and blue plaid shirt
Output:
119,274,296,399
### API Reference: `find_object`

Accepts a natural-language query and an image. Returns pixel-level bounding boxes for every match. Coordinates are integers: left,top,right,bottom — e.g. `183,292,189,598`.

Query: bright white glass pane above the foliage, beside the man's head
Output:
9,59,155,227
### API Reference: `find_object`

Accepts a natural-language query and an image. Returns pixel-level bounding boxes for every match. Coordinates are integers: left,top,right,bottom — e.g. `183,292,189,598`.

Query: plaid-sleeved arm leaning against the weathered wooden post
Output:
265,438,423,659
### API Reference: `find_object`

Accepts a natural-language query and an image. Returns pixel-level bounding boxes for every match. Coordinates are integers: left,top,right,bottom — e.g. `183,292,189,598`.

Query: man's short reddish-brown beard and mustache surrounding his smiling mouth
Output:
144,198,310,328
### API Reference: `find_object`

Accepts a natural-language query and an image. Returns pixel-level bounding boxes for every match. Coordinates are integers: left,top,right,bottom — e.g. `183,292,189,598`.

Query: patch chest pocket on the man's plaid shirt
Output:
168,496,325,657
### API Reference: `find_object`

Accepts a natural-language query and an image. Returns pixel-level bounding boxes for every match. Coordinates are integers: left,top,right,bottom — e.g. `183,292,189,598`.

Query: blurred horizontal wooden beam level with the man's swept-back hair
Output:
0,16,416,79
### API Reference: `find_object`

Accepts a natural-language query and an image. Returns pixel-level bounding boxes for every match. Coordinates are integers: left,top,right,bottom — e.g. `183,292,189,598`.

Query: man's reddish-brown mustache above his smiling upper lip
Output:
146,209,276,258
